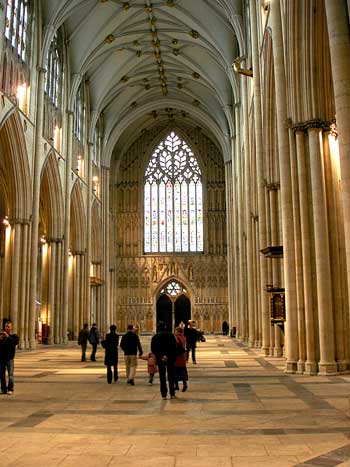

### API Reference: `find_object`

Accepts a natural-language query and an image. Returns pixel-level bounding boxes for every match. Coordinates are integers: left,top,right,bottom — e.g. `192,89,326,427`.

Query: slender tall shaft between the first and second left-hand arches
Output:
29,68,45,349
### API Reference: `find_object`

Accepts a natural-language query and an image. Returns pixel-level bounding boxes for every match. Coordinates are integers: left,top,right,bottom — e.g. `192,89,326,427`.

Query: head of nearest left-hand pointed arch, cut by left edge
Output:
0,111,32,220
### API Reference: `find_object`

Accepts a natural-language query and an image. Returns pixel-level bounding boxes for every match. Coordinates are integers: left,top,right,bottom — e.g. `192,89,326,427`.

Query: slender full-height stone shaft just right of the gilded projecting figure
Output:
250,1,270,355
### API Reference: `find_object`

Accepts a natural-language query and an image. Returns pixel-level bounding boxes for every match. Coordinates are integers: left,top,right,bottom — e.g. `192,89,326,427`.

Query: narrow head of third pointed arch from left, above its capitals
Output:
69,180,86,252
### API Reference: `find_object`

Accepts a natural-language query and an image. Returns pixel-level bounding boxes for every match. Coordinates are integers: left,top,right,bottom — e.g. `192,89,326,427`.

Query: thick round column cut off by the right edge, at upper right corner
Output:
325,0,350,310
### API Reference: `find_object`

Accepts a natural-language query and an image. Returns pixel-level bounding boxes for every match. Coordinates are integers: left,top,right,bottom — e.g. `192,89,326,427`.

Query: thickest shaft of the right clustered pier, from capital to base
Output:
308,128,337,374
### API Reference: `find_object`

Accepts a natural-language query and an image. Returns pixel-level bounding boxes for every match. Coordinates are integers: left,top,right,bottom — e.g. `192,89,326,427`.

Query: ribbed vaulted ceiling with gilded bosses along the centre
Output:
43,0,242,165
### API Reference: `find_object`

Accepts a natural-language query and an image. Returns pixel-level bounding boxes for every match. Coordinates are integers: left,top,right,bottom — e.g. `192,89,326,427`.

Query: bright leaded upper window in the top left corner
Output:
5,0,29,61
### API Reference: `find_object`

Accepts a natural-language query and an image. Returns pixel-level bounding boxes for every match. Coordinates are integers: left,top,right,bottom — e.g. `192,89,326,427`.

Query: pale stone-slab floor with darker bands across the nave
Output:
0,336,350,467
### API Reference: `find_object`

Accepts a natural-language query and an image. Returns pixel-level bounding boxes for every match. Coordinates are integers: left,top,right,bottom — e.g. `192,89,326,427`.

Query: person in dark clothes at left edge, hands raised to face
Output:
0,321,19,395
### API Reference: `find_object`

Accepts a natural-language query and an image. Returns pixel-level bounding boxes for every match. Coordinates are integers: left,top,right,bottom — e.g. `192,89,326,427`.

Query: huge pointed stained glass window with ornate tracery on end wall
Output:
144,132,203,253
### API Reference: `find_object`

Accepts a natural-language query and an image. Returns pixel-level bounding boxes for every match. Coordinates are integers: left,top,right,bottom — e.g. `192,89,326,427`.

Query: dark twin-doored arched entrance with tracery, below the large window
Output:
156,280,191,332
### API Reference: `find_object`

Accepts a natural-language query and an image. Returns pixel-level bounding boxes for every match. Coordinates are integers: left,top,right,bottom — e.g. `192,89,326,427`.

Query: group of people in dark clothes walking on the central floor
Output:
78,321,198,399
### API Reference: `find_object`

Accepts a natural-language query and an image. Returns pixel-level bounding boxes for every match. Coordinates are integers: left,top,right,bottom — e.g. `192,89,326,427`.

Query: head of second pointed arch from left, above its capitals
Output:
40,152,64,238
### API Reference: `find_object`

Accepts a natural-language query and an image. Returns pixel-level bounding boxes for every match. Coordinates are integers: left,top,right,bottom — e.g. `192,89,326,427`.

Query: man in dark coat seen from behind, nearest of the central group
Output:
151,322,176,399
